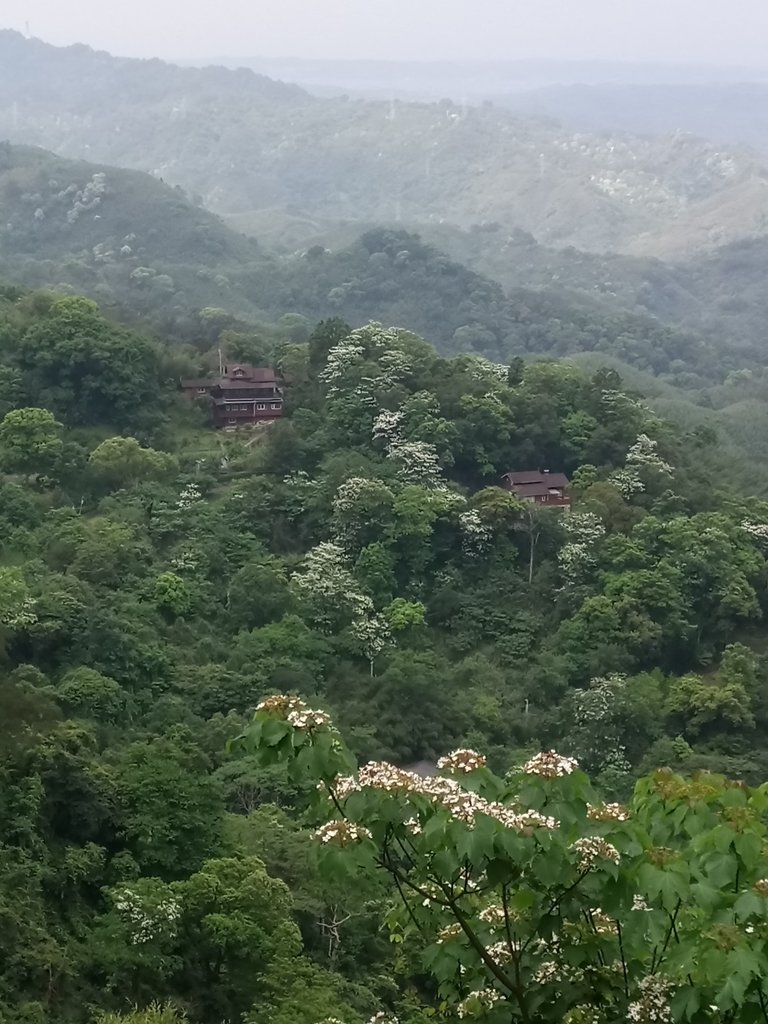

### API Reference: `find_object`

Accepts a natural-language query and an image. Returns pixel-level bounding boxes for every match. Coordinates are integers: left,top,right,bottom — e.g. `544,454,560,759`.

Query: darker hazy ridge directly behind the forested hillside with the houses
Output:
0,143,720,383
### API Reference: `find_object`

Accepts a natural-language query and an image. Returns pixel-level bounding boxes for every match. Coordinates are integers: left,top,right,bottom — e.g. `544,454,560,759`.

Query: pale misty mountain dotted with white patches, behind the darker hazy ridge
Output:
0,32,768,255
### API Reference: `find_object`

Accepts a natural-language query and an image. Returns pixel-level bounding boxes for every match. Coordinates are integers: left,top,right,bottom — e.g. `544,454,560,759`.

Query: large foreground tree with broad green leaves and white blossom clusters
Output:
234,696,768,1024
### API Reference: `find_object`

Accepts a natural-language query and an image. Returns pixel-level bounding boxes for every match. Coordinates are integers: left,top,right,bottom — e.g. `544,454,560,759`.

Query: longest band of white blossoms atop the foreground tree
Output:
336,761,558,835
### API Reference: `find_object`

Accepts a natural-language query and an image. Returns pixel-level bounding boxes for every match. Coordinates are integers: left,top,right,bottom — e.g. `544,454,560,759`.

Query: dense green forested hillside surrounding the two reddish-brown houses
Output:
0,287,768,1024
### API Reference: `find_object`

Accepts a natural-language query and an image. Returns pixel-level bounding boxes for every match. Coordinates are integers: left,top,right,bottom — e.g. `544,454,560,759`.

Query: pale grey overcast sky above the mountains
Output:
0,0,768,65
